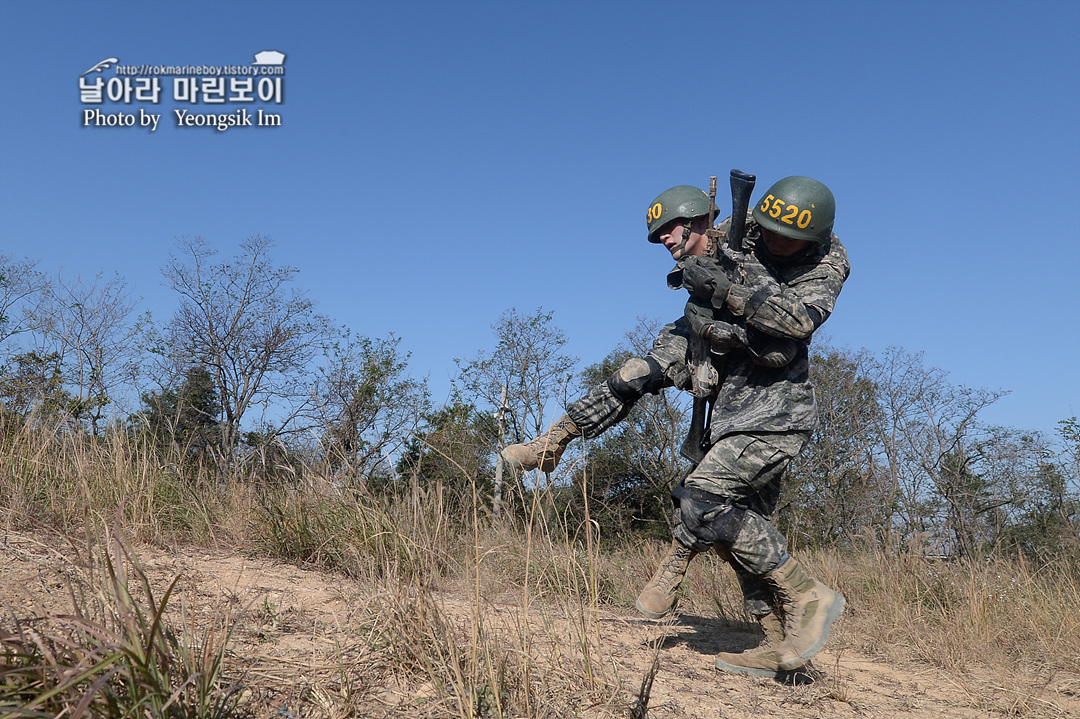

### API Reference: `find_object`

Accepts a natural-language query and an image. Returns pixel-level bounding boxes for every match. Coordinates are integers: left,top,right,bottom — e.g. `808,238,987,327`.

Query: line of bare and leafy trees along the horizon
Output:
0,235,1080,556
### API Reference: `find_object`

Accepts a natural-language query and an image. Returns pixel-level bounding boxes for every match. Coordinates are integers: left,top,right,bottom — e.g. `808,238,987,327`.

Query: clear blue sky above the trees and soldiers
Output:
0,0,1080,431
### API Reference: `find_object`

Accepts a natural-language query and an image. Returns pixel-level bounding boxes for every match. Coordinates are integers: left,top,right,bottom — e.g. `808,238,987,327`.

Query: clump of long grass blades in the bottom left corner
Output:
0,520,240,719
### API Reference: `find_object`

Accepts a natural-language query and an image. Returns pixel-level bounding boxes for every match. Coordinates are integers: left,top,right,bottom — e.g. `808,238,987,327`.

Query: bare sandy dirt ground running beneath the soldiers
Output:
0,533,1080,719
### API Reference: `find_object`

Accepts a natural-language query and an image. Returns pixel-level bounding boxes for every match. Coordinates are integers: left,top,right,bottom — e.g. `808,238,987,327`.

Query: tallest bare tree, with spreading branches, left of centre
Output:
162,235,329,447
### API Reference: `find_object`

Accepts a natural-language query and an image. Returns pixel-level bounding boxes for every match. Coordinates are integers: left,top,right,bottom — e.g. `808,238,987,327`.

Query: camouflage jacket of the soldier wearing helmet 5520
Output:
710,215,850,442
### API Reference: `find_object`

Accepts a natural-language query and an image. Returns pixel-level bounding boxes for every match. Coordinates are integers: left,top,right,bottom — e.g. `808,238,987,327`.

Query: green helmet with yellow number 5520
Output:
754,176,836,244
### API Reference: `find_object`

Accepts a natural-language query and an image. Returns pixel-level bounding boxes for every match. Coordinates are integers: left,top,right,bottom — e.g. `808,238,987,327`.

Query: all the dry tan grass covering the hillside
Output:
0,416,1080,719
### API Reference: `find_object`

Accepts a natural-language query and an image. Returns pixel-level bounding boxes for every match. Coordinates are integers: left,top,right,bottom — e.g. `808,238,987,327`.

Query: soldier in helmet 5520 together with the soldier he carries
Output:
502,177,850,677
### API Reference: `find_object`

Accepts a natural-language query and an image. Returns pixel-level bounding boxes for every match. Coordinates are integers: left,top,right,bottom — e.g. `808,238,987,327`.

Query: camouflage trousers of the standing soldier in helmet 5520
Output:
672,432,809,615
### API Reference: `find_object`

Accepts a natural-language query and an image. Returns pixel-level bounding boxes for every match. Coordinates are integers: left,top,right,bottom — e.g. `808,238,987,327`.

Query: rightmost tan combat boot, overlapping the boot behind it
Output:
764,557,846,671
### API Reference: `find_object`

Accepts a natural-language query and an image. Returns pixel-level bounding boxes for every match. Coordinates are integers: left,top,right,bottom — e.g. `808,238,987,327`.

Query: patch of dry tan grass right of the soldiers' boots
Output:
833,551,1080,673
